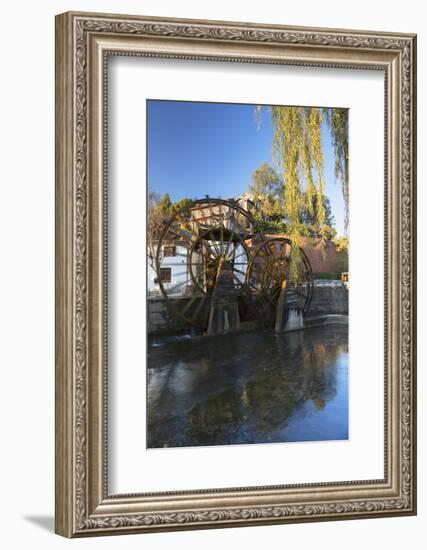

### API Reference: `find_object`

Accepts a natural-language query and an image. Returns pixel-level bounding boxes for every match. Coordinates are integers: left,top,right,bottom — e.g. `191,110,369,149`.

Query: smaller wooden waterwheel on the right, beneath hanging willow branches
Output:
246,237,313,326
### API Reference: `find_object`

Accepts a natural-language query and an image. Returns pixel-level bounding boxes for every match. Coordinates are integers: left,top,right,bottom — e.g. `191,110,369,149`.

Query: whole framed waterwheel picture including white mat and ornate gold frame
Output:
56,12,416,537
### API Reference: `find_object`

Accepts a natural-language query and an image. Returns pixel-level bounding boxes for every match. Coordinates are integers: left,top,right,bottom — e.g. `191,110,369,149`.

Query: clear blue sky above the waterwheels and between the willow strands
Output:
147,100,344,234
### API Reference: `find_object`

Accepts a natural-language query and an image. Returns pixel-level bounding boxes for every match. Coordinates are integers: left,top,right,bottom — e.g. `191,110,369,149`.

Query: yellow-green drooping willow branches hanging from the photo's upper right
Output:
257,107,348,279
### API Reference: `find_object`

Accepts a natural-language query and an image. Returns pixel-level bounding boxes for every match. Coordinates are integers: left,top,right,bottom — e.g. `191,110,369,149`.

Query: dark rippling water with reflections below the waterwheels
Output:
147,326,348,448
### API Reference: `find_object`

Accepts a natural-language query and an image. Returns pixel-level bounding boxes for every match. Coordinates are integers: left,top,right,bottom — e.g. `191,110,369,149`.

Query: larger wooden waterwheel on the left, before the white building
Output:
156,198,255,329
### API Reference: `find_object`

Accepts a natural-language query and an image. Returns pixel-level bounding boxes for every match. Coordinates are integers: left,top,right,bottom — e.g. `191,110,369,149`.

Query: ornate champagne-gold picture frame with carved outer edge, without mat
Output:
55,12,416,537
